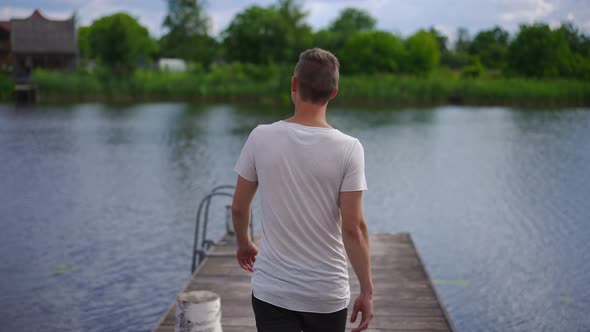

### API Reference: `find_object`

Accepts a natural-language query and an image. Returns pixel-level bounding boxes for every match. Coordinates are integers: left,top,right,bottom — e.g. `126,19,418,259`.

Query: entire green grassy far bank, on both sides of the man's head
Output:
3,65,590,106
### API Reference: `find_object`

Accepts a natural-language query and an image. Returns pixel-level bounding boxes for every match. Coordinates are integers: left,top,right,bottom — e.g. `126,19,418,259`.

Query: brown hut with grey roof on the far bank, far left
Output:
0,10,78,83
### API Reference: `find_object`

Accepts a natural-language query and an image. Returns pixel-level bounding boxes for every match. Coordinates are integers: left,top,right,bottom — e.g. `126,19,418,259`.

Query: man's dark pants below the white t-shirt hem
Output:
252,294,348,332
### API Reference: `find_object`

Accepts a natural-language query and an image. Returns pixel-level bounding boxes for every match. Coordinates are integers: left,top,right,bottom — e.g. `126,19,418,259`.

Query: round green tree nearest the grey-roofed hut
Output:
88,13,158,76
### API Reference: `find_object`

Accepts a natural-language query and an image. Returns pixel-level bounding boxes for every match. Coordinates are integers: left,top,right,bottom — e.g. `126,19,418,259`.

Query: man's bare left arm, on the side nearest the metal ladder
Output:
232,176,258,272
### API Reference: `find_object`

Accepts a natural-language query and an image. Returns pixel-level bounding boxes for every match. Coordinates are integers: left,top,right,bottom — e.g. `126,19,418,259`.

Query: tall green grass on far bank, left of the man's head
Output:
29,66,288,100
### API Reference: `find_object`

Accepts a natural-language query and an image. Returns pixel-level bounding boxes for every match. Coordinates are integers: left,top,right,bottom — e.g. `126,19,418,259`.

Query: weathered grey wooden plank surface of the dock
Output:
153,233,454,332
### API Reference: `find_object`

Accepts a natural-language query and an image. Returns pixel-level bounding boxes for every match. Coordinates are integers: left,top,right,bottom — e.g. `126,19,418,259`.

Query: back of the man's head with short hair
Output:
295,48,340,105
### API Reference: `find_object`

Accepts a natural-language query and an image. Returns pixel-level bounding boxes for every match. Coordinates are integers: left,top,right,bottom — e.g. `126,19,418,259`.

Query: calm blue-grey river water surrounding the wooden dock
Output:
0,103,590,331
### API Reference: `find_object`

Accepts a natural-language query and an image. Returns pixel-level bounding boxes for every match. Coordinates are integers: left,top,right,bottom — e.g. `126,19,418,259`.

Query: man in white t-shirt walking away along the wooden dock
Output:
232,48,373,332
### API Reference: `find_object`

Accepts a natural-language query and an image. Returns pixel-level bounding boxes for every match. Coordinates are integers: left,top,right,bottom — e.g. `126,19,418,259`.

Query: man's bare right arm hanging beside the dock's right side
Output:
340,191,373,332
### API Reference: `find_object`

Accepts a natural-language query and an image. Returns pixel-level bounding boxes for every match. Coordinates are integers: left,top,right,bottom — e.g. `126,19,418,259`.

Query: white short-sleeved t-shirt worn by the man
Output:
234,120,367,313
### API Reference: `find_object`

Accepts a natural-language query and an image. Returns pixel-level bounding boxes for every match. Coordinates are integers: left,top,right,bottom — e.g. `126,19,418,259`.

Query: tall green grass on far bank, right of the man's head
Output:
339,75,590,105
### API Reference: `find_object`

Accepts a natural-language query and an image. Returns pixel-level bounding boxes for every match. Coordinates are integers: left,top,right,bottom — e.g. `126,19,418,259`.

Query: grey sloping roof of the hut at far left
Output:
10,10,78,54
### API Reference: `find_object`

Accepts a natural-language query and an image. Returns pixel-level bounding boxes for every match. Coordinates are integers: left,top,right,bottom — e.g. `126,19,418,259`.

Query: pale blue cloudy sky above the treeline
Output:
0,0,590,41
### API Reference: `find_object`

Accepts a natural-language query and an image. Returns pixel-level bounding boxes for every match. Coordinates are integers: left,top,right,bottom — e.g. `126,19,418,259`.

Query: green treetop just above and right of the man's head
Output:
314,8,377,53
